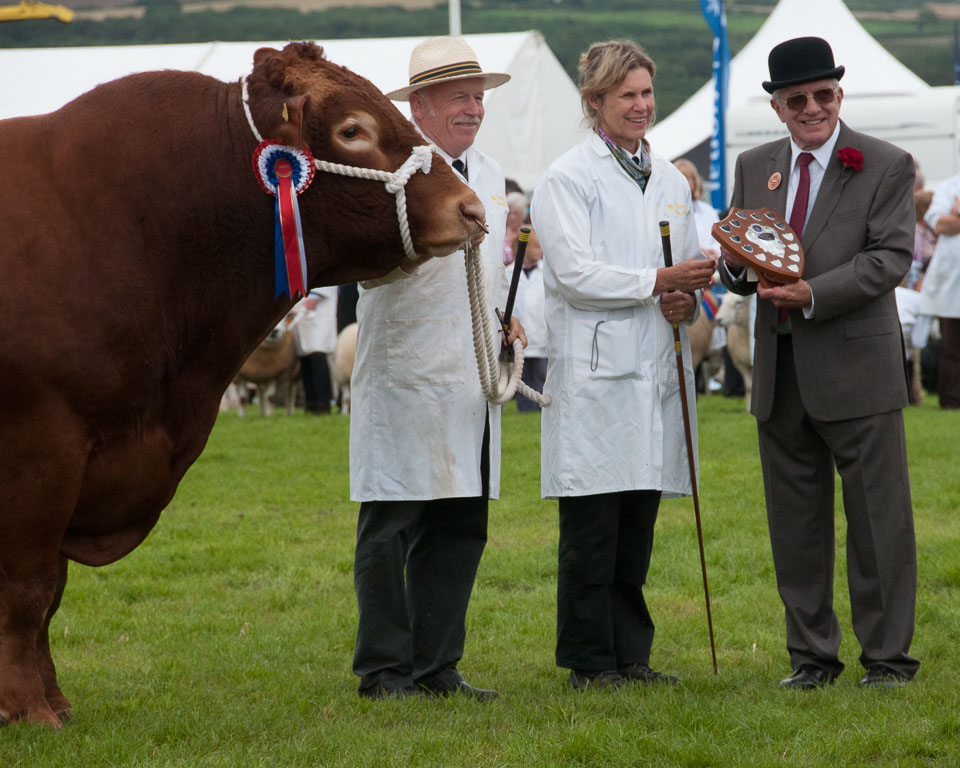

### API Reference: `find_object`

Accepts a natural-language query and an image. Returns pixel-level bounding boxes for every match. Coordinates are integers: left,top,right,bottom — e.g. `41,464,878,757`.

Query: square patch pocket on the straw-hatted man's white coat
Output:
386,315,463,387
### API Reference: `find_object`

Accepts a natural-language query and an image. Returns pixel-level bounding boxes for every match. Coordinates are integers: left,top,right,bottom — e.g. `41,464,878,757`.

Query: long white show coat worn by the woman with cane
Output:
531,134,701,498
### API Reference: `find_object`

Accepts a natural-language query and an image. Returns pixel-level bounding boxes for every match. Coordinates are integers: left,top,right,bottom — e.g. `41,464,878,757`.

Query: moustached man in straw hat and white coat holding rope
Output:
350,37,523,701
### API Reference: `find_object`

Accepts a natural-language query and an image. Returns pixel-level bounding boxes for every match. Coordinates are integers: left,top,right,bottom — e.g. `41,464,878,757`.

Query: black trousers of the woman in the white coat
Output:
557,491,660,671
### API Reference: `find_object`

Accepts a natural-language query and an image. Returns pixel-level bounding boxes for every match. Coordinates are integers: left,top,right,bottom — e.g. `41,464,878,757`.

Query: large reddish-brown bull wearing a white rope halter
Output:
0,43,483,727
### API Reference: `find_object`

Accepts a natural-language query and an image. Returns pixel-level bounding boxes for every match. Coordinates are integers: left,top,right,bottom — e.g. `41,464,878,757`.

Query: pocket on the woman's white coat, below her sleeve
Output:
573,315,639,384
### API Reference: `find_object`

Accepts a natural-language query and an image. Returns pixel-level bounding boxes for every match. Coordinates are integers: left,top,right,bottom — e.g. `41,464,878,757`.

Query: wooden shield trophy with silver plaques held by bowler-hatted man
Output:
711,208,804,288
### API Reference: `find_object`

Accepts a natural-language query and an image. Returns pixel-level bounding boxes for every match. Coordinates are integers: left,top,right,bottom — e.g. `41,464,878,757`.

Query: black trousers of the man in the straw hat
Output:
353,425,490,689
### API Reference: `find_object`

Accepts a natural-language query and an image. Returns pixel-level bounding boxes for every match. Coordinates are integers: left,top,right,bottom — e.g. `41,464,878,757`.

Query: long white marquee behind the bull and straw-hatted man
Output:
0,32,582,190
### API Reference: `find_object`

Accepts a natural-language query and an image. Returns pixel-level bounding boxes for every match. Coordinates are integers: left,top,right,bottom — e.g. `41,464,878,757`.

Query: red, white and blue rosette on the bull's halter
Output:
253,139,316,299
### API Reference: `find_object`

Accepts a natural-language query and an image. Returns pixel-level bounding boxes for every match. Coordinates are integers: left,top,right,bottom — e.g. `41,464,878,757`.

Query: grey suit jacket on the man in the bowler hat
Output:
720,122,916,421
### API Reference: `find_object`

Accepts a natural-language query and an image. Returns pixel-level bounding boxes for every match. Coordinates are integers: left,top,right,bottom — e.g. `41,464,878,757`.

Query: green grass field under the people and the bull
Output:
0,396,960,768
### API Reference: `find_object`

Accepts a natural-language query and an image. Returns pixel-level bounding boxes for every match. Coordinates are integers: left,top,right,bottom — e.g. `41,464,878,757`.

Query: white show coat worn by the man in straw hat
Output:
350,142,508,501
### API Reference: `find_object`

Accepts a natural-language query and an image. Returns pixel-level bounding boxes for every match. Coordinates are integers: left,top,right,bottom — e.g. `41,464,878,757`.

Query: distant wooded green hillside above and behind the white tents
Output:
0,0,953,118
